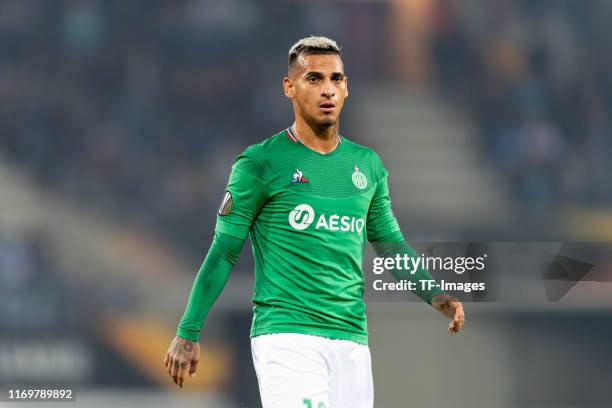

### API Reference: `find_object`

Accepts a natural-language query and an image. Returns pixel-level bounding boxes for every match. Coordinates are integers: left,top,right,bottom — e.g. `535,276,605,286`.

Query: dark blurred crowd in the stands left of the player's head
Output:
0,0,388,258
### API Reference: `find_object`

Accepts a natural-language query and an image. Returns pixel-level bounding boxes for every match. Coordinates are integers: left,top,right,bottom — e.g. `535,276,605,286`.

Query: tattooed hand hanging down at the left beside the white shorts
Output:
164,336,200,388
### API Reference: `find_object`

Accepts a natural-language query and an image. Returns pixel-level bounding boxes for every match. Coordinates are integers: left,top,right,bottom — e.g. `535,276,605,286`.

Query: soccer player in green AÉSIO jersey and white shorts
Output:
165,37,464,408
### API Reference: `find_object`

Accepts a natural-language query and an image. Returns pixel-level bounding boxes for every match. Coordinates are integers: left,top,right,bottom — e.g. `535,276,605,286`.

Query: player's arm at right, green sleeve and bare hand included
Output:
366,168,465,334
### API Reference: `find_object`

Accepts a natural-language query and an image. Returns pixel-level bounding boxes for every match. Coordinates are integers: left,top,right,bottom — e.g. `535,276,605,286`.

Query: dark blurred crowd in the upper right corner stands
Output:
432,0,612,207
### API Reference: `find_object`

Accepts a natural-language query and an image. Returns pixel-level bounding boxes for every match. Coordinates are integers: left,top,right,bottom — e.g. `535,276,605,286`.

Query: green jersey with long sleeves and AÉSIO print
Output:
177,129,441,344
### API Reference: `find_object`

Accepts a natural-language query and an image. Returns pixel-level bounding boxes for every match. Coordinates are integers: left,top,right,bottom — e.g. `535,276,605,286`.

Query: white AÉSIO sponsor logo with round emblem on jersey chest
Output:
289,204,365,234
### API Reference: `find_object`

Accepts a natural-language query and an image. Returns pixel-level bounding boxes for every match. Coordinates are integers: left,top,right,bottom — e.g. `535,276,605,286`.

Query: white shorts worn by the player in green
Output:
251,333,374,408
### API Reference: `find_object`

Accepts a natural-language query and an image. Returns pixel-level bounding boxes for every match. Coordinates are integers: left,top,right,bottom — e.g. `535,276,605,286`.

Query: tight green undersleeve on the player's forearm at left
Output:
176,232,244,341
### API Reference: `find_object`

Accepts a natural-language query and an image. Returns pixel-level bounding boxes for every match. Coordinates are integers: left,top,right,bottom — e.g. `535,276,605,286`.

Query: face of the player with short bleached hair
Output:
283,54,348,127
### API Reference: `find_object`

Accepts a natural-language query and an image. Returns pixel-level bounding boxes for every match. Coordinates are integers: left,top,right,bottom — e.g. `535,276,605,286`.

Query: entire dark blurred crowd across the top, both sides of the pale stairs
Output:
0,0,612,259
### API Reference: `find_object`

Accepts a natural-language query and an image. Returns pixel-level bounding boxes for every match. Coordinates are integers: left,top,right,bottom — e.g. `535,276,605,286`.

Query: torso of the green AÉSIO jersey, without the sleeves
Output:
245,131,377,342
